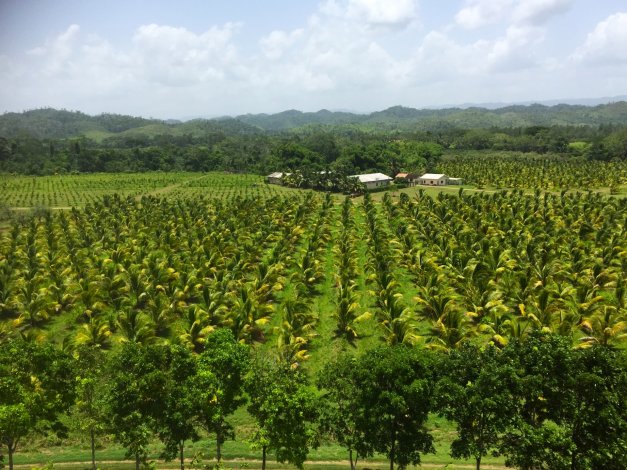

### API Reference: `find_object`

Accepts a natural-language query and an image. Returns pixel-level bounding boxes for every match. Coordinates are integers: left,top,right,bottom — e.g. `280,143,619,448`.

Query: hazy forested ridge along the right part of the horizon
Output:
236,101,627,131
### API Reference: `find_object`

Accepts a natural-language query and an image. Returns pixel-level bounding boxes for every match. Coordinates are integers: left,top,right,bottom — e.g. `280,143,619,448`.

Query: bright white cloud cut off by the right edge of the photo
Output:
572,12,627,65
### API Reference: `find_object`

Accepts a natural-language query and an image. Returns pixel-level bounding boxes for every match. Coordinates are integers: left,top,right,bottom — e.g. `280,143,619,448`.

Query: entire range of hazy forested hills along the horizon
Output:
0,101,627,141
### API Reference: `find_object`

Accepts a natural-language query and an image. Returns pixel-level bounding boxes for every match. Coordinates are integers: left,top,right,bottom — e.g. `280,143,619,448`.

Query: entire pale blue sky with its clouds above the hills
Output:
0,0,627,119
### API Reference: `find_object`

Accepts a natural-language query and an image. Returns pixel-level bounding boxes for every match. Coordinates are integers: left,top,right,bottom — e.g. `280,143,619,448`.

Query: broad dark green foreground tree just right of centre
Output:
355,345,435,470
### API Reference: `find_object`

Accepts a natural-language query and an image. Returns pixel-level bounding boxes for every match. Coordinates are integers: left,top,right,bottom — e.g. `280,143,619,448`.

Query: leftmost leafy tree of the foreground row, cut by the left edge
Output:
0,340,74,470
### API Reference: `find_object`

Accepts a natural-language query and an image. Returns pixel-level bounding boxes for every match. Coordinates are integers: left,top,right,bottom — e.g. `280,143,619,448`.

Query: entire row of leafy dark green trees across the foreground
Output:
0,328,627,470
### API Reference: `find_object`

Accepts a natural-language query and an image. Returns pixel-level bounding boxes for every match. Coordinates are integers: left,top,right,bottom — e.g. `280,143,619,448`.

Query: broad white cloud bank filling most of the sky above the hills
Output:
0,0,627,117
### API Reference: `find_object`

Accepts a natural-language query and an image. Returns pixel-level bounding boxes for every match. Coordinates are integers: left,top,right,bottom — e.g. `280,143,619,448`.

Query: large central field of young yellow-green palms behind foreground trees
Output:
0,186,627,348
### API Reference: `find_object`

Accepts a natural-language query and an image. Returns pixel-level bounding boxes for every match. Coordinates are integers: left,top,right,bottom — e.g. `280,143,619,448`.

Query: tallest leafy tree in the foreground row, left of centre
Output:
192,328,249,462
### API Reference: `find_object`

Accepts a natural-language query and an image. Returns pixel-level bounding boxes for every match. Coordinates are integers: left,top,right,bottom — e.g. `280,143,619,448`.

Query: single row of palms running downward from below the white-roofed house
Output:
363,193,419,345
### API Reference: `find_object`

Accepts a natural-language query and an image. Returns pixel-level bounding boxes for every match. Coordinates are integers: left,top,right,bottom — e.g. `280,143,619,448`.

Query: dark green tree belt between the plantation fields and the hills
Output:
0,125,627,175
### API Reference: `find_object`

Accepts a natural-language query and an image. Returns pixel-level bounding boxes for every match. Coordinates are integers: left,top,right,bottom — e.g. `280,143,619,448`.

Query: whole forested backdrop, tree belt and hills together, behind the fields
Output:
0,103,627,175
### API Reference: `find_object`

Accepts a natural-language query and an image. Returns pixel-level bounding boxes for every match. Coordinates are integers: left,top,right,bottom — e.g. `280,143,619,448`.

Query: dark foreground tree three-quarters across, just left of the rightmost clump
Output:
436,343,513,470
